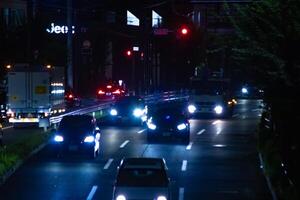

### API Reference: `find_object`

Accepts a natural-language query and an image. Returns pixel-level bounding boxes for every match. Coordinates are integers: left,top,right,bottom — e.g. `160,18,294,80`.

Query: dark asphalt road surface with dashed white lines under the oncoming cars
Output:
0,100,271,200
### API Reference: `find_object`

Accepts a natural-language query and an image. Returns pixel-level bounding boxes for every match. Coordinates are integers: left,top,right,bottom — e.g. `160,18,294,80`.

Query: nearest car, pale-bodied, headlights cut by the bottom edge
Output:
113,158,171,200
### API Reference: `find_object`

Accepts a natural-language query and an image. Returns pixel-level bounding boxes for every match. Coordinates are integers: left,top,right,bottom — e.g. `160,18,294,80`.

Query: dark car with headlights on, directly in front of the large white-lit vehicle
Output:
146,104,190,143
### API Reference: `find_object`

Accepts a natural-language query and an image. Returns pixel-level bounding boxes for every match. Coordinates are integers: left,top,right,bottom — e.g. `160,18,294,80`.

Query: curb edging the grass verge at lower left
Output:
0,142,47,186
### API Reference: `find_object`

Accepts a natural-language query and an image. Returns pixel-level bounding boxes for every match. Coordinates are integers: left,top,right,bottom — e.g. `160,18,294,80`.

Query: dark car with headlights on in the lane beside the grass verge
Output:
52,115,101,158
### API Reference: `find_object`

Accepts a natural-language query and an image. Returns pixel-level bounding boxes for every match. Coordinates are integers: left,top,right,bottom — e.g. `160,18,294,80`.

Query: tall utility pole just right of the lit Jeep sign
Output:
67,0,73,89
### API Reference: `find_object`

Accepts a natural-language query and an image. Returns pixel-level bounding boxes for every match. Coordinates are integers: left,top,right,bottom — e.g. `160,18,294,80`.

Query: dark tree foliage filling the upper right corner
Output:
225,0,300,85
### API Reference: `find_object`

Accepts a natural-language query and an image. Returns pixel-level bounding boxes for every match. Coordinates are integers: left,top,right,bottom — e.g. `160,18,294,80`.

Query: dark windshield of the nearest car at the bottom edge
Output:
116,168,168,187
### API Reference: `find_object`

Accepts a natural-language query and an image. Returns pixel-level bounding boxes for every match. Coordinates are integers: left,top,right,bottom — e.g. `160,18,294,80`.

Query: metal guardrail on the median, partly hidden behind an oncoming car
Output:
48,90,189,127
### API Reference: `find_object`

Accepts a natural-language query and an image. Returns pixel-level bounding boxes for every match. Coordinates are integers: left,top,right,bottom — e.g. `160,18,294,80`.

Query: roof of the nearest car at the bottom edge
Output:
121,158,166,170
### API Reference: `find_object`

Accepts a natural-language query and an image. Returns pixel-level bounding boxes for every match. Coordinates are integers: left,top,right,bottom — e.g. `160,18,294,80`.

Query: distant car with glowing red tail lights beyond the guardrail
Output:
97,84,125,100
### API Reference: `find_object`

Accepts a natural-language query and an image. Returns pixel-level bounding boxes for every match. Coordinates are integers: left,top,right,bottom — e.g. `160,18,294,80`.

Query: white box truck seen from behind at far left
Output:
7,64,65,127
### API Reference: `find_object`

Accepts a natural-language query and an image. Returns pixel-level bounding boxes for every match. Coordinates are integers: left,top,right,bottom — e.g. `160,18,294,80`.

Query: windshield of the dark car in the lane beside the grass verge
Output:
58,116,93,134
